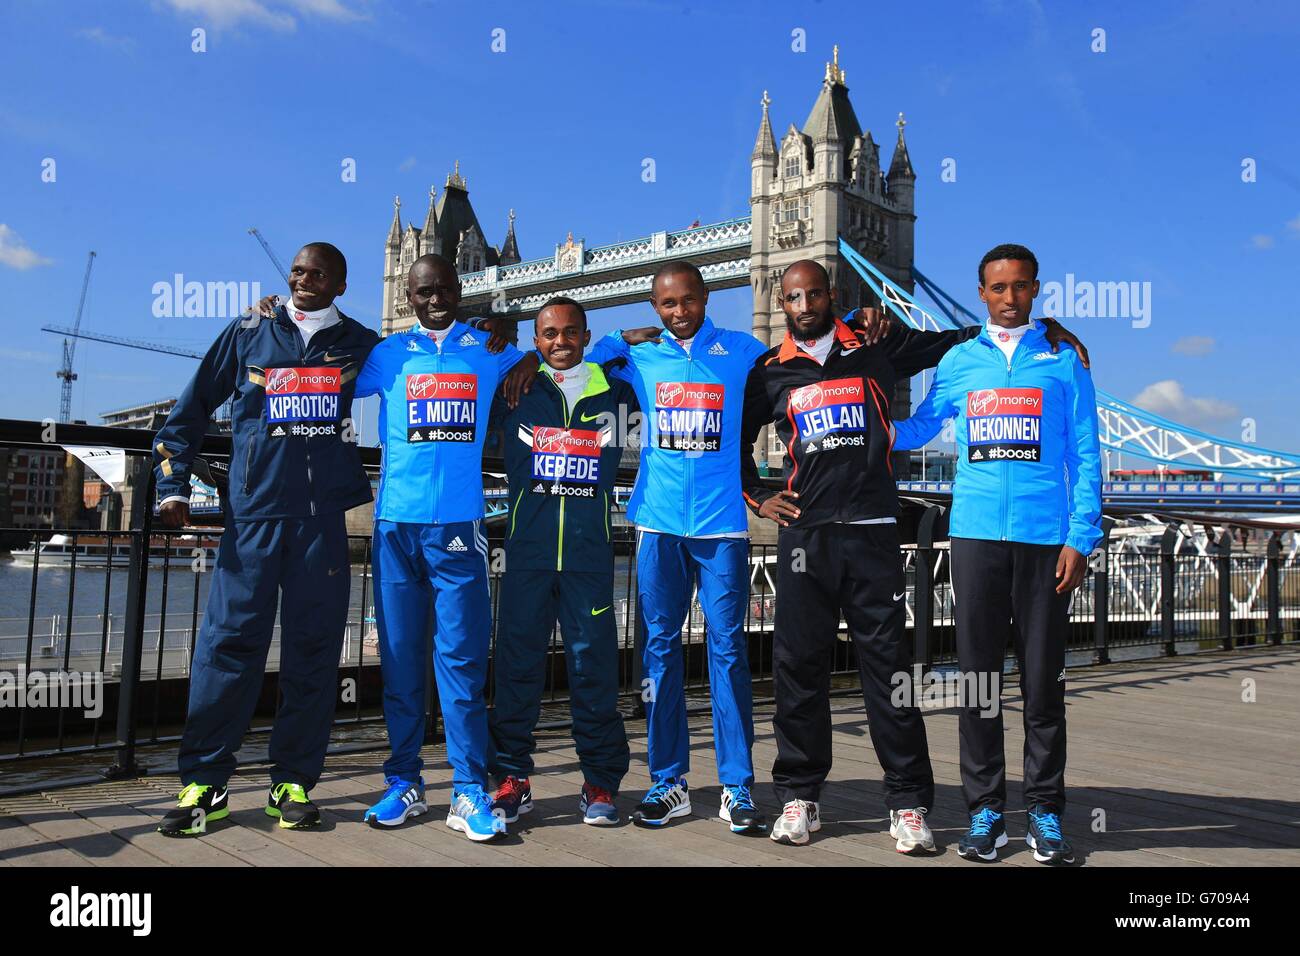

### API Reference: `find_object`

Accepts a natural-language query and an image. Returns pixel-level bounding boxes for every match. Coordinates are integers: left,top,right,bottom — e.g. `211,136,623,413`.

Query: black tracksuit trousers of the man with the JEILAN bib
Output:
772,524,935,810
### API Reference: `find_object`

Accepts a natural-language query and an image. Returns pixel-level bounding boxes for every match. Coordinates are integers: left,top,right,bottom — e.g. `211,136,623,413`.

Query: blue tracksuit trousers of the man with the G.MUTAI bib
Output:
637,532,754,786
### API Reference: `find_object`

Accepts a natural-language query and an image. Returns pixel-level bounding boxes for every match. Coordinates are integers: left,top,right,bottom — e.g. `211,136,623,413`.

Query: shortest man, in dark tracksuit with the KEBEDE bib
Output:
490,297,636,826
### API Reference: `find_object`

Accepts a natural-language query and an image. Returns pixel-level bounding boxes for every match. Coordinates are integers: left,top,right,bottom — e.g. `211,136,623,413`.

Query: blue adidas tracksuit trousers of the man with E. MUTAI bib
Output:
374,520,491,787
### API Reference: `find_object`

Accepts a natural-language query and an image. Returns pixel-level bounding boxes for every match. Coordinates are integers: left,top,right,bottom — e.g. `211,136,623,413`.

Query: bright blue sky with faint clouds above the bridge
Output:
0,0,1300,450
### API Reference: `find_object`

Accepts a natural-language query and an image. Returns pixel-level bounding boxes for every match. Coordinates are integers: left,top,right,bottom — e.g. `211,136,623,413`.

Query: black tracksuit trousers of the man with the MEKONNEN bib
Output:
952,537,1070,813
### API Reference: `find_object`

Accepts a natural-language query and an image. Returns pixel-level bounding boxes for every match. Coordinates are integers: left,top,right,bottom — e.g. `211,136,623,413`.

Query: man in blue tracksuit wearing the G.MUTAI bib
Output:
589,261,767,832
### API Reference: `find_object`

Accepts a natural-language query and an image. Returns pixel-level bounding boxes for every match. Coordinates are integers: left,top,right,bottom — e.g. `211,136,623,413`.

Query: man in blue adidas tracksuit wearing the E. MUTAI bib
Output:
356,255,537,842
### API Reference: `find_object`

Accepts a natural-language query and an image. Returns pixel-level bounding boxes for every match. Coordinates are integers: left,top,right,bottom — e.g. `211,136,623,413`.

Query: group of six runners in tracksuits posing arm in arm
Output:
155,243,1100,862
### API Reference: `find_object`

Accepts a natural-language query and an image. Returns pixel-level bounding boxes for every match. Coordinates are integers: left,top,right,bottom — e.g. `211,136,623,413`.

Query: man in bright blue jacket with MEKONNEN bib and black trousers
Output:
894,245,1101,864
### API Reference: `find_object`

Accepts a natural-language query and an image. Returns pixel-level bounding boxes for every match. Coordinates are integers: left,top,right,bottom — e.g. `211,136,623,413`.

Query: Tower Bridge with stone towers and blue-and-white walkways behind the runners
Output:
381,48,1300,511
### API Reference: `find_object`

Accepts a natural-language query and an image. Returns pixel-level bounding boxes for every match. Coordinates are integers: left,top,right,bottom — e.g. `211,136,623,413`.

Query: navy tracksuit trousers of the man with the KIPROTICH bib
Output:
178,511,351,790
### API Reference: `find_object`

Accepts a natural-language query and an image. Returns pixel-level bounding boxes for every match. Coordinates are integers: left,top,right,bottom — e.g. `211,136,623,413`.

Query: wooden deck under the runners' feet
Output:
0,648,1300,866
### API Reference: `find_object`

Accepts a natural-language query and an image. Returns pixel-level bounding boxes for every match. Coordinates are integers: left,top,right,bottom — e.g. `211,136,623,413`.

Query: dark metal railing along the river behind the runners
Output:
0,428,1300,790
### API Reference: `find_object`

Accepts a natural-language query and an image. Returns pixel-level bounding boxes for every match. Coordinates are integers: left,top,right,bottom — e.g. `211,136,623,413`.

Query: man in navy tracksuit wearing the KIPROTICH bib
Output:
153,242,378,836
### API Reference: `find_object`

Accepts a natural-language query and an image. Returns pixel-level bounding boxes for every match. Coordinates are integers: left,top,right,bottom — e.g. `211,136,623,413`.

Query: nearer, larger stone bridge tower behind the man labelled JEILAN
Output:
749,47,917,471
